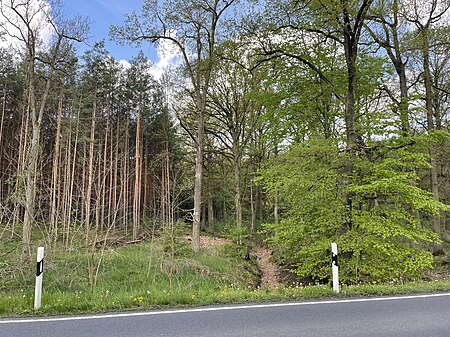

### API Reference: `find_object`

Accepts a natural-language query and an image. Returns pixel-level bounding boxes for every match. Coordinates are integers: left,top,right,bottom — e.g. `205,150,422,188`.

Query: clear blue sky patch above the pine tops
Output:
61,0,158,63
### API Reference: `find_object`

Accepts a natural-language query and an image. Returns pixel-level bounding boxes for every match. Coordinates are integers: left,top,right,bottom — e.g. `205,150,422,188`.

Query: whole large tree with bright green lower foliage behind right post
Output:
253,1,448,283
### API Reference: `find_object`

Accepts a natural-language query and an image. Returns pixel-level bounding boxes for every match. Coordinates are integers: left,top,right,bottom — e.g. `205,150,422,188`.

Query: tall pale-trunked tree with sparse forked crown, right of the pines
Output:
112,0,237,252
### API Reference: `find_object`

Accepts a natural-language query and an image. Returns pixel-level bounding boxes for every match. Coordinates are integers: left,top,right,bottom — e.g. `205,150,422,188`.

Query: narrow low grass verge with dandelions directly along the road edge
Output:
0,281,450,317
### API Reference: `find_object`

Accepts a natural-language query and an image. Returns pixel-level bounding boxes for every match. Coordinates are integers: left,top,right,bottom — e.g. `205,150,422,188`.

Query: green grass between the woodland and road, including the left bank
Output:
0,232,450,316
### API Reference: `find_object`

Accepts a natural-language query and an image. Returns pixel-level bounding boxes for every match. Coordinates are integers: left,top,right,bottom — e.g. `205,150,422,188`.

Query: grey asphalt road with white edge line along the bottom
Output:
0,293,450,337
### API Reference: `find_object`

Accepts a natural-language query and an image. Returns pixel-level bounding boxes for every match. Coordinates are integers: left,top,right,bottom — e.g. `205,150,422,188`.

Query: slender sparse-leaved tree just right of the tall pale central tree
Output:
206,41,265,227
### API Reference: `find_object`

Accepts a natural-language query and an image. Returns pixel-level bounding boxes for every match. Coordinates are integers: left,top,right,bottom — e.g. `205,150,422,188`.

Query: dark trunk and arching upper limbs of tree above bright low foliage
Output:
256,0,373,238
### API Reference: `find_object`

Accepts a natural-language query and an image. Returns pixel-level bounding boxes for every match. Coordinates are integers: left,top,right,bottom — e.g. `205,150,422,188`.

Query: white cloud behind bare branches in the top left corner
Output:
0,0,54,49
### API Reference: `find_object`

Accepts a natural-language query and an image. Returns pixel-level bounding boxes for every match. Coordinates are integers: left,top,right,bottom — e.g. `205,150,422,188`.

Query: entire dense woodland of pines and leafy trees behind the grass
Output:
0,0,450,283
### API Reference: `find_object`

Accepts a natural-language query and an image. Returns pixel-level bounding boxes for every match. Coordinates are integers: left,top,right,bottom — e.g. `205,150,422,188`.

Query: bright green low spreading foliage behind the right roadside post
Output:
259,139,449,283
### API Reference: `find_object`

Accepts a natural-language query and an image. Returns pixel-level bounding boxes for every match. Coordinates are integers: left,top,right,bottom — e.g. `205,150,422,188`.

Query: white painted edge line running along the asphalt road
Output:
0,293,450,324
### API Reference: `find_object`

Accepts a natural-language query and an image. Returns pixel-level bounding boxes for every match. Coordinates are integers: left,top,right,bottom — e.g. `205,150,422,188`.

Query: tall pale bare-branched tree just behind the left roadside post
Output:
1,0,87,260
